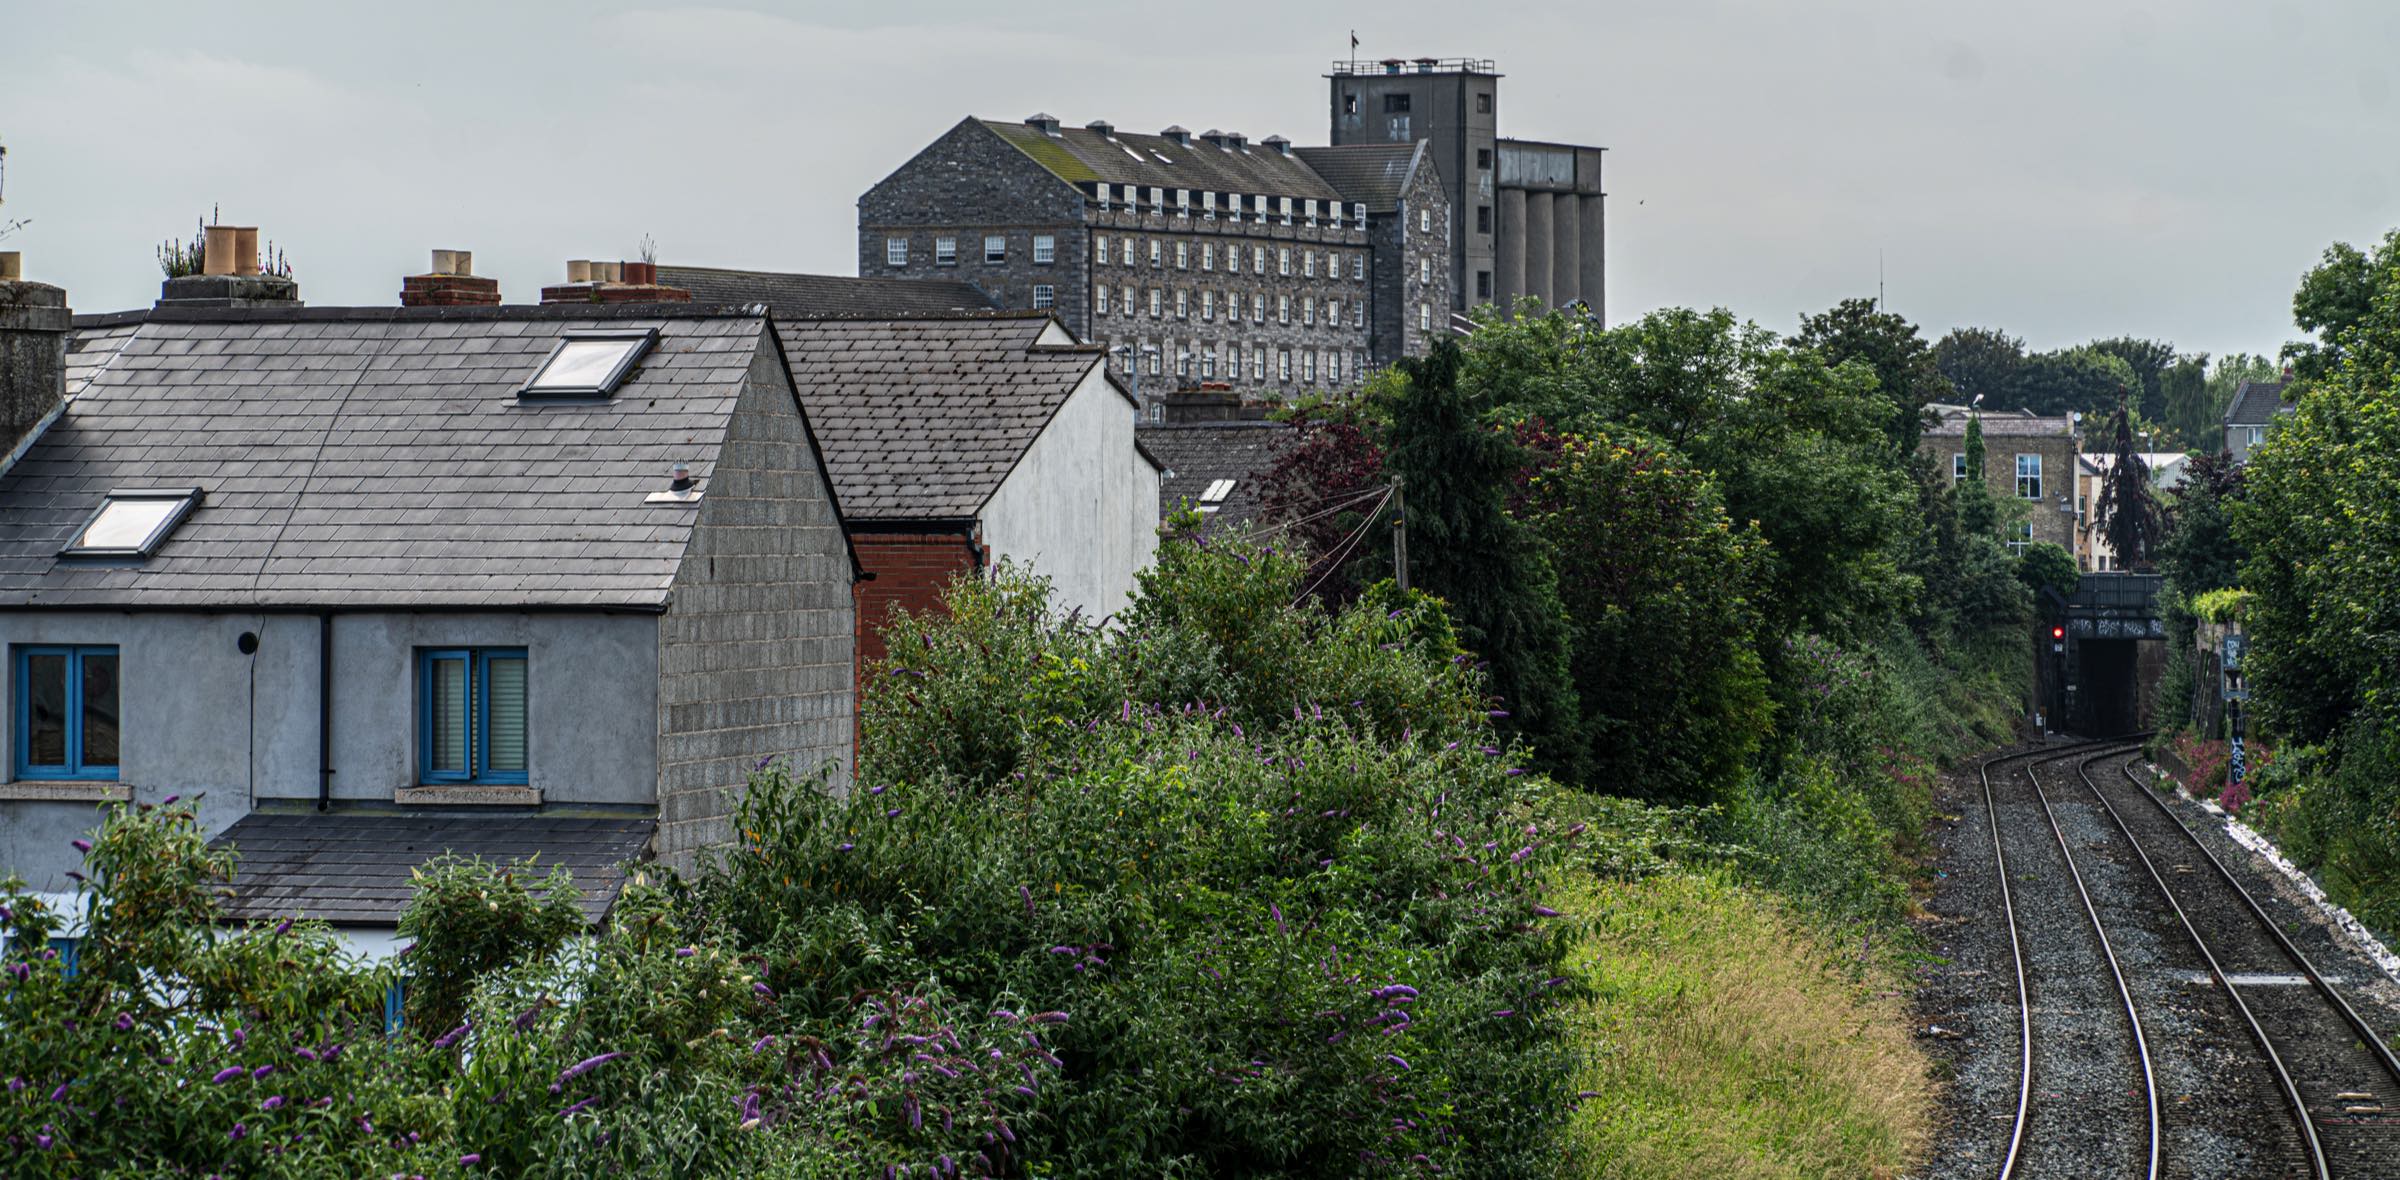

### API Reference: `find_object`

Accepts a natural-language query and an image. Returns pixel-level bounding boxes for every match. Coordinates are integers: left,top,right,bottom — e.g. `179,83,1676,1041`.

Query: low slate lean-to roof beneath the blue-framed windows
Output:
209,811,658,926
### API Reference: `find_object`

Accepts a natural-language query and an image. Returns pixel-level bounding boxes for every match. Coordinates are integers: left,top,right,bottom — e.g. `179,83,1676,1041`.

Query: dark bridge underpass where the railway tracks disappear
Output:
2035,573,2167,736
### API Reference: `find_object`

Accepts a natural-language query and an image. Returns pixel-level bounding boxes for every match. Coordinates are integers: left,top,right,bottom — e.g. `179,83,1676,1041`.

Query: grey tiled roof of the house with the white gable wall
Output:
778,317,1102,520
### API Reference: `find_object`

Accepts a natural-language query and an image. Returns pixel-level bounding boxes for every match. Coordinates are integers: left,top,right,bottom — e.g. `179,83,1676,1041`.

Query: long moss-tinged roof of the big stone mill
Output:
977,120,1342,201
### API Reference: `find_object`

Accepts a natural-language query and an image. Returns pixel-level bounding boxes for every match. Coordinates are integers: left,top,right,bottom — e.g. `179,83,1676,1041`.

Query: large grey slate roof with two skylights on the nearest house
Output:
0,307,766,609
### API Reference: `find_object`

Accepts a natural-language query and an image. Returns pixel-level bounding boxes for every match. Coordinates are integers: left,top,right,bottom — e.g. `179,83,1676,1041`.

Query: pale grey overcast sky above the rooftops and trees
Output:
0,0,2400,353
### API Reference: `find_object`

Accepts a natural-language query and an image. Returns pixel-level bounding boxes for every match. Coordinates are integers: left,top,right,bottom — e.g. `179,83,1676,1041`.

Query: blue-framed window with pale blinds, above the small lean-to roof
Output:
418,648,528,784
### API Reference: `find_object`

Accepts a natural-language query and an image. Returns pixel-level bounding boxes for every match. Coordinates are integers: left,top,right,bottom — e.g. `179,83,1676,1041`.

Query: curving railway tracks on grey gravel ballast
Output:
1980,739,2400,1180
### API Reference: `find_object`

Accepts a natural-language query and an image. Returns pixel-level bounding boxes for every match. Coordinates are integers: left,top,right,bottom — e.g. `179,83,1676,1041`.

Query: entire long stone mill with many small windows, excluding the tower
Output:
859,115,1452,417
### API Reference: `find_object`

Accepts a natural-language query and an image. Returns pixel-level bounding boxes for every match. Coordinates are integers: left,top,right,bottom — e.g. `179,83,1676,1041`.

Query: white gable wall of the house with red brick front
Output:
982,365,1159,621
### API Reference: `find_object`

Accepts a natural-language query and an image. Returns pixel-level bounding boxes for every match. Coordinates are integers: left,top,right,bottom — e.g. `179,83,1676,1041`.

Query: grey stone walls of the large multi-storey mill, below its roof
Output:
859,120,1452,403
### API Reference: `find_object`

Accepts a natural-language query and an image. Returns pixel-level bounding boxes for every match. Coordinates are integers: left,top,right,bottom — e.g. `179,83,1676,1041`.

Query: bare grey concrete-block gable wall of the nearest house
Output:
658,341,857,871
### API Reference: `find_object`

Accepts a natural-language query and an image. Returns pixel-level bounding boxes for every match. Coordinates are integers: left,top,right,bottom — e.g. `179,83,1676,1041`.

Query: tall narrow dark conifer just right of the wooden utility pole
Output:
1378,341,1582,779
